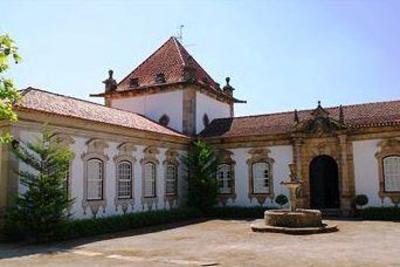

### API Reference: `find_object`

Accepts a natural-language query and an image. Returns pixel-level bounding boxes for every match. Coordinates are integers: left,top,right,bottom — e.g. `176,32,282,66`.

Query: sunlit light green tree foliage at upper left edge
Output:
0,35,21,143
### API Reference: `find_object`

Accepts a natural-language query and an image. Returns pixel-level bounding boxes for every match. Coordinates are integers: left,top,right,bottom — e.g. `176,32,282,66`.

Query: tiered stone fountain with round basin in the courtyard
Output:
250,164,338,234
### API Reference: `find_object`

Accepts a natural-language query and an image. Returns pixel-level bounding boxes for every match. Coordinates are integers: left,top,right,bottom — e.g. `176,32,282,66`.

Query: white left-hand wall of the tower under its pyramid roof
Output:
111,90,183,132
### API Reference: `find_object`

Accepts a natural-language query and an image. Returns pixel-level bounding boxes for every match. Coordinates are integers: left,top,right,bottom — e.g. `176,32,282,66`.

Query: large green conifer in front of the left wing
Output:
6,130,72,241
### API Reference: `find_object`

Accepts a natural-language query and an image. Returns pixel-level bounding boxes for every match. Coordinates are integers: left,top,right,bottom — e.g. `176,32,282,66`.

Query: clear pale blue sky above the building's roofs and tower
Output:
0,0,400,115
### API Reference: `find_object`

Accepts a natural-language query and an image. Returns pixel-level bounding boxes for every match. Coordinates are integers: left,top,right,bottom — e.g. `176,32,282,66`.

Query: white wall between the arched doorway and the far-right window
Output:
353,139,393,207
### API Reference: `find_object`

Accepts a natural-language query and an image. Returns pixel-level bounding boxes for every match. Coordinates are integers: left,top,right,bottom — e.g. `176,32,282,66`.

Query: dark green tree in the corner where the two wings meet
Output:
183,141,219,211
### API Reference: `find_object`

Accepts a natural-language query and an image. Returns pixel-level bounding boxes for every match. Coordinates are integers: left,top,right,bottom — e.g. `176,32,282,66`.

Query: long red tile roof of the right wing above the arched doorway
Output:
200,100,400,137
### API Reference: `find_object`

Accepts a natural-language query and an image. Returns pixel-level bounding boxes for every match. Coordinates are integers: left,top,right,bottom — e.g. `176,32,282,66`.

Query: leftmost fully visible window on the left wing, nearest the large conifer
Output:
87,159,104,200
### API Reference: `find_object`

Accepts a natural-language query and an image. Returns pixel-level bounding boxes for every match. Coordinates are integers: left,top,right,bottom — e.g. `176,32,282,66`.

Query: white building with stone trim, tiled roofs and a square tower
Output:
0,37,400,218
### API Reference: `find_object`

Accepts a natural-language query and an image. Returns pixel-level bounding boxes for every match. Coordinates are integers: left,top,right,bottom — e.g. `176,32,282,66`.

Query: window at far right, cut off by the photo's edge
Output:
383,156,400,192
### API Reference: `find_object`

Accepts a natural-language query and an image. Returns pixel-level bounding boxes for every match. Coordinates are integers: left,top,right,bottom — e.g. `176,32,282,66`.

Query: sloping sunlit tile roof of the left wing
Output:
16,87,188,137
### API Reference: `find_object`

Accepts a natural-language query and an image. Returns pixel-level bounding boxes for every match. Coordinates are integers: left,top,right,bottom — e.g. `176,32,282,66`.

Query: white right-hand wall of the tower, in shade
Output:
196,92,230,133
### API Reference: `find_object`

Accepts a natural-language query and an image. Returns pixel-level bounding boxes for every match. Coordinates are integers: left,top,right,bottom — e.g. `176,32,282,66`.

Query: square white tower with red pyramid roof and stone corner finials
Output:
92,37,244,135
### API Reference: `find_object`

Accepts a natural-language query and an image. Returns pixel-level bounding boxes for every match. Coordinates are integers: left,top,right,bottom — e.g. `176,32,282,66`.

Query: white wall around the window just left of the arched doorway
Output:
228,145,293,207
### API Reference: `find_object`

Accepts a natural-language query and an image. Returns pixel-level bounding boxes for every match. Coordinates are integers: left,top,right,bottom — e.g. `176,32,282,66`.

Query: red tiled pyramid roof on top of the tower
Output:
117,37,218,91
